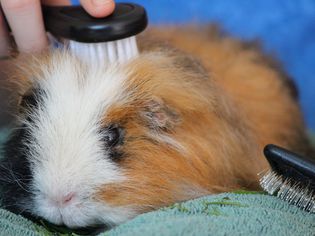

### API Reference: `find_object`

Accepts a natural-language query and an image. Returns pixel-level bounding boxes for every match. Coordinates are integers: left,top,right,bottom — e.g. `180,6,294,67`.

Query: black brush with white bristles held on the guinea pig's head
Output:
43,3,148,64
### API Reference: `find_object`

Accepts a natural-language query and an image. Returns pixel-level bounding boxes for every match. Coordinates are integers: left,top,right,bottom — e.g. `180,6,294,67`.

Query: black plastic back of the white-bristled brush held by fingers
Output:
5,3,148,43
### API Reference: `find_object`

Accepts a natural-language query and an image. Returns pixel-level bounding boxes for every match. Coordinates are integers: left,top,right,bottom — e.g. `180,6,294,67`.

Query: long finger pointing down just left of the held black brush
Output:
0,0,48,52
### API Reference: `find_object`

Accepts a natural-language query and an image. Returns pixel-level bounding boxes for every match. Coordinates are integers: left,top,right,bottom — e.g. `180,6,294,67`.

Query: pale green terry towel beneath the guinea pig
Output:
0,131,315,236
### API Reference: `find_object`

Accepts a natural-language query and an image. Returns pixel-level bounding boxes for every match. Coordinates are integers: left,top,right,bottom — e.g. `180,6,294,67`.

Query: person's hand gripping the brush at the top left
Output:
0,0,115,58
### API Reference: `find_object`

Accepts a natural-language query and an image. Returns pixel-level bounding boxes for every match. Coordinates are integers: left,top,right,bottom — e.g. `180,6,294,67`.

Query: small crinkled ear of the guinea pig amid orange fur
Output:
142,97,181,130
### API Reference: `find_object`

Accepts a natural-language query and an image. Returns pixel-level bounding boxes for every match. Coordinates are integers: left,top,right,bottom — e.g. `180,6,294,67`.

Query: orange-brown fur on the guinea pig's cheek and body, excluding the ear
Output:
98,26,309,212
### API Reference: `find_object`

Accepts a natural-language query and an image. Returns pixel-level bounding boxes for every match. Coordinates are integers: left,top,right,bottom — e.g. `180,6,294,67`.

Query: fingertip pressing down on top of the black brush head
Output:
80,0,115,17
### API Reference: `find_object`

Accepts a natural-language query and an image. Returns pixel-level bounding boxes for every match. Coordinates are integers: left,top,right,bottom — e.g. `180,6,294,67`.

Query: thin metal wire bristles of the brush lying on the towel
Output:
260,171,315,213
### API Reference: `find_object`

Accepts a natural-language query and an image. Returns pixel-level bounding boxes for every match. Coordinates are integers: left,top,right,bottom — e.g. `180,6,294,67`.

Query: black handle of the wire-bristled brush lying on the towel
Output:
264,144,315,189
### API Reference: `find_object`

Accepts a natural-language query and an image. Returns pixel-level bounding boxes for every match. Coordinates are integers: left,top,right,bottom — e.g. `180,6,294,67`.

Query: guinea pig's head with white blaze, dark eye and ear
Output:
1,52,216,228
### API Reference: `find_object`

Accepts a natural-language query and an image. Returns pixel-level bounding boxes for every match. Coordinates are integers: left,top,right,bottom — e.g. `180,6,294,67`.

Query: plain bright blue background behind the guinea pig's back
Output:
74,0,315,131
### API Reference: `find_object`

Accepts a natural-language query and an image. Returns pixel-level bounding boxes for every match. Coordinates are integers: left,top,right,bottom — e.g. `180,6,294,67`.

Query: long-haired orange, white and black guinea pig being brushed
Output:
0,28,310,228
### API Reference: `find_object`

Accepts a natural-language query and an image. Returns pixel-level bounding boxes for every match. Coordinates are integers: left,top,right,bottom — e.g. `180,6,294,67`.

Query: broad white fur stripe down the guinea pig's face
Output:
25,53,133,227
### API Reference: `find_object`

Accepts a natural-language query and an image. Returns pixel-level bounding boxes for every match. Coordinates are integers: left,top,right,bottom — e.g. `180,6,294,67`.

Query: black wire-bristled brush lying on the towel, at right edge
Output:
260,144,315,213
